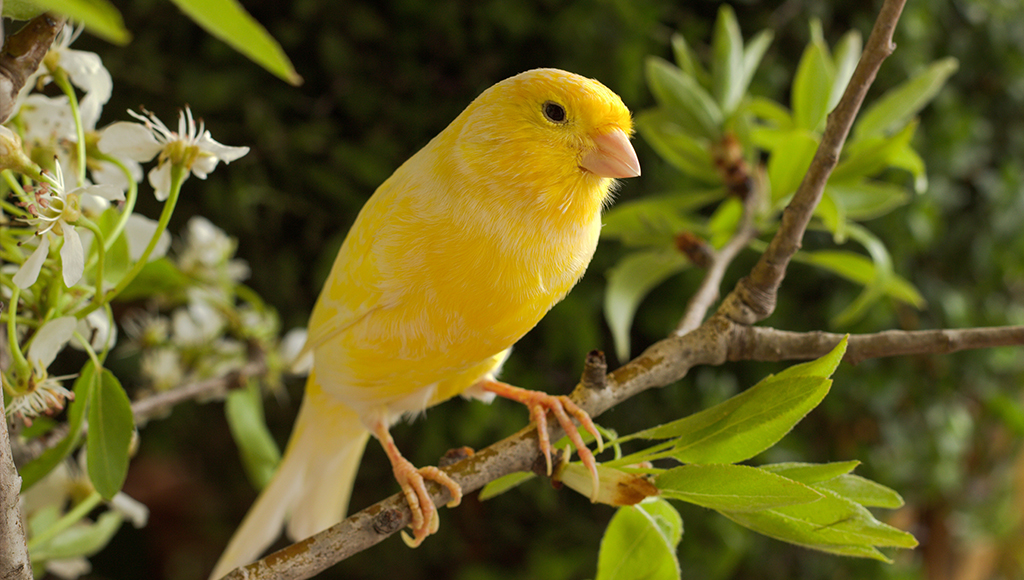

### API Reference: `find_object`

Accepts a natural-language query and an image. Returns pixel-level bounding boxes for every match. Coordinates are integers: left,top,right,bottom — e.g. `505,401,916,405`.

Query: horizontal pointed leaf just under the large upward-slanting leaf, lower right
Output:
655,464,821,511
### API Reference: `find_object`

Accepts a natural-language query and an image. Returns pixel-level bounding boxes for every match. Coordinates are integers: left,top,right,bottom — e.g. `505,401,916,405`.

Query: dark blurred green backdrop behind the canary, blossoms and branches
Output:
64,0,1024,580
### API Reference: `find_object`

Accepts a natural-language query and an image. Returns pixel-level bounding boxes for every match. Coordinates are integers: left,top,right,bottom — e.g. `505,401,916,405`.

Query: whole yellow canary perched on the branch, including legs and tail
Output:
211,69,640,578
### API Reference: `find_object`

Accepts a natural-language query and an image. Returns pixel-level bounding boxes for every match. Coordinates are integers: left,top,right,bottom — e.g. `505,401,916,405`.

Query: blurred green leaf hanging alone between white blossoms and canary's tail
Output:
224,380,281,490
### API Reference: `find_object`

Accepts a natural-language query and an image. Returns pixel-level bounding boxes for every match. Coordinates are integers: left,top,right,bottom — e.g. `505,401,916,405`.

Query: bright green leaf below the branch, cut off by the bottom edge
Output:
596,500,682,580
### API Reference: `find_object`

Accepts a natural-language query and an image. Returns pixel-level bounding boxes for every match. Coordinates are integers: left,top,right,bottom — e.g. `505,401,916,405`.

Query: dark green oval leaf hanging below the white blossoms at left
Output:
86,369,135,499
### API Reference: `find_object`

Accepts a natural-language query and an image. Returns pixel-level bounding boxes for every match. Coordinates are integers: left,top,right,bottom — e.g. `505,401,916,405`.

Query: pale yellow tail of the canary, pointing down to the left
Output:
210,374,370,579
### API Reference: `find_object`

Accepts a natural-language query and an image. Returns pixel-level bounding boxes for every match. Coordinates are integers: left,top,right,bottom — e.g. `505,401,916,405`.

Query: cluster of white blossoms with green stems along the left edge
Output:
0,20,305,578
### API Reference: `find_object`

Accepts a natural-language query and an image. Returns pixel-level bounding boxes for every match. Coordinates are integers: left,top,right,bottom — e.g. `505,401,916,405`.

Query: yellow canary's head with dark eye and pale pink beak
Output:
454,69,640,212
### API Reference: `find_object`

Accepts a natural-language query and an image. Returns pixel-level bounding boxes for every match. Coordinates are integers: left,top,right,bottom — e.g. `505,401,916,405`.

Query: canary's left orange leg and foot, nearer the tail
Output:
374,422,462,548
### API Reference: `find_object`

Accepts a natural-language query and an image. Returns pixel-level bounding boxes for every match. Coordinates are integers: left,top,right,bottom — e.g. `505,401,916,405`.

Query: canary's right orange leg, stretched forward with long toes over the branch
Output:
480,380,604,499
